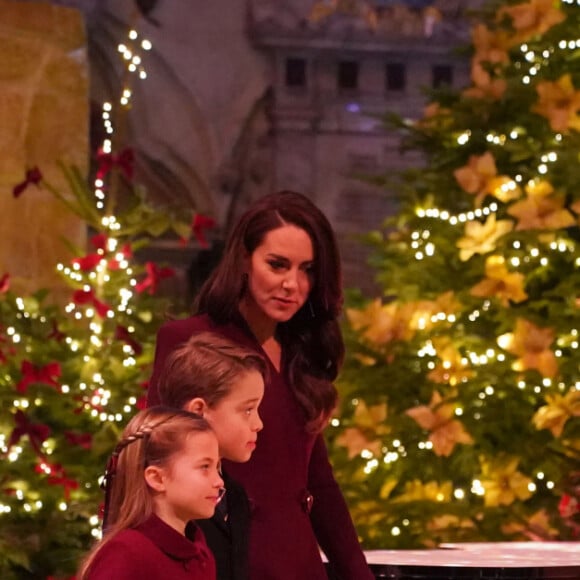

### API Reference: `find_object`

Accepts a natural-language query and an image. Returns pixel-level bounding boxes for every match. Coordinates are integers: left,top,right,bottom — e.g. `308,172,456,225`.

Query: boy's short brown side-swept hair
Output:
158,332,268,409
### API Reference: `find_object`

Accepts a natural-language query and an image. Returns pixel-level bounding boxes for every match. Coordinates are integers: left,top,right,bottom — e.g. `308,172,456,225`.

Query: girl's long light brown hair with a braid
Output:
78,407,211,580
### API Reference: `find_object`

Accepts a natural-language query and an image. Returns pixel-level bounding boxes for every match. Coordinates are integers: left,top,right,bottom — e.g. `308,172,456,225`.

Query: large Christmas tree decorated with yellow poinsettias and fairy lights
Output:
329,0,580,548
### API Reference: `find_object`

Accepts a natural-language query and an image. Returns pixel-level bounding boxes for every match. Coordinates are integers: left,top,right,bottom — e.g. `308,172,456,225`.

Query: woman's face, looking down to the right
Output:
246,224,314,323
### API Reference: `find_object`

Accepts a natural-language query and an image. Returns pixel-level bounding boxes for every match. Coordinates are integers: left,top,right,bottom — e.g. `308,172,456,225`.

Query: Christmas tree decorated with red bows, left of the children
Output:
0,21,206,579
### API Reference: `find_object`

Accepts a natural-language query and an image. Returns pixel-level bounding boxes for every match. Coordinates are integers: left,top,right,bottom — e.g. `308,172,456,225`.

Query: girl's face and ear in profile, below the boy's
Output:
145,431,224,534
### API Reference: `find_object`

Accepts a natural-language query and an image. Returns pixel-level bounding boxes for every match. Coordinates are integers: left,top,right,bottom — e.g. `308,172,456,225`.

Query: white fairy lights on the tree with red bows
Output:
0,24,152,538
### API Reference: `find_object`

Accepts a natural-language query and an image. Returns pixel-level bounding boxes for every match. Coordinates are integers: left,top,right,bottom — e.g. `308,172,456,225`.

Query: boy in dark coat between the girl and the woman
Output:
156,332,266,580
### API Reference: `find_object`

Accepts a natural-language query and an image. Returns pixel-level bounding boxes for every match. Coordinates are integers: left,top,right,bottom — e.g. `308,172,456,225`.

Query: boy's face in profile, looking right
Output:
203,370,264,462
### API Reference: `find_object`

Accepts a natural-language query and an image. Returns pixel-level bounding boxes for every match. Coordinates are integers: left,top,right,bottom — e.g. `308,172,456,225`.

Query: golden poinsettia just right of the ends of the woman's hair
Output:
336,401,389,459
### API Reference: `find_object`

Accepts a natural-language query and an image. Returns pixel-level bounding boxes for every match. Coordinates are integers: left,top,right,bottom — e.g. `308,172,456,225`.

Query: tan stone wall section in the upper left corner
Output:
0,0,88,292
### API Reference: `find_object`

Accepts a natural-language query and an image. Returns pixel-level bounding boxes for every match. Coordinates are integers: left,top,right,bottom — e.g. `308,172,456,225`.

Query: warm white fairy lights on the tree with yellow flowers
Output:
331,23,580,536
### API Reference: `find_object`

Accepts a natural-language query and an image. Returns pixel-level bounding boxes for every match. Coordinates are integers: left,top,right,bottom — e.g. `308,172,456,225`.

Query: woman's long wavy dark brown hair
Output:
194,191,344,430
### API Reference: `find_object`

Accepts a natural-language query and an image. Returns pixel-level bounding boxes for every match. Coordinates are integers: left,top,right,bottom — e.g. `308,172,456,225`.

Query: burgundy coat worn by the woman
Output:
148,315,374,580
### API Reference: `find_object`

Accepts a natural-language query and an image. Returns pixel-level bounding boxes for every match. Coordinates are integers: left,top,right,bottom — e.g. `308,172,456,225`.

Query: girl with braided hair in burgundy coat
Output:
78,407,223,580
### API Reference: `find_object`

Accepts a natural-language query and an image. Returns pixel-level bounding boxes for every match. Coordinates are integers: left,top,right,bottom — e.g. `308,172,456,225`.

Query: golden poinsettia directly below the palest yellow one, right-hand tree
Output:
469,256,528,308
